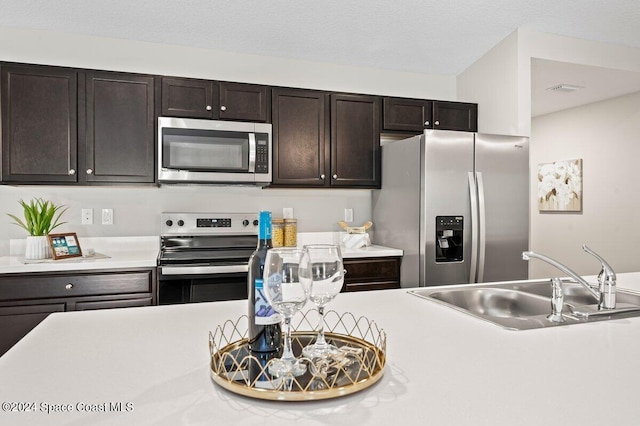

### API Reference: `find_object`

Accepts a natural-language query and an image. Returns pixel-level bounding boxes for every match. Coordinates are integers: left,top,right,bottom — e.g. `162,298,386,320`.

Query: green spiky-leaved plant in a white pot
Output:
7,198,68,259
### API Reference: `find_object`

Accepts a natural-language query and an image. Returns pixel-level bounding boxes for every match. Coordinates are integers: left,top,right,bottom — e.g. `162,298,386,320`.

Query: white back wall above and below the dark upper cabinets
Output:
0,27,456,256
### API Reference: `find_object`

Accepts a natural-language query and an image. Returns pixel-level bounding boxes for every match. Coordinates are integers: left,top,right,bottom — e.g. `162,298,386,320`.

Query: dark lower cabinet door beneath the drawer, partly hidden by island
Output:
0,303,65,356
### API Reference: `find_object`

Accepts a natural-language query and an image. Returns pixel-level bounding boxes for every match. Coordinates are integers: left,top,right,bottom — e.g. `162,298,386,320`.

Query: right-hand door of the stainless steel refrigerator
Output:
475,134,529,282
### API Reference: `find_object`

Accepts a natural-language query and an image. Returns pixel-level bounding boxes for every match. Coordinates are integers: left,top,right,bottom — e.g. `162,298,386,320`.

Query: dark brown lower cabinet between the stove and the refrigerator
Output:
342,257,402,291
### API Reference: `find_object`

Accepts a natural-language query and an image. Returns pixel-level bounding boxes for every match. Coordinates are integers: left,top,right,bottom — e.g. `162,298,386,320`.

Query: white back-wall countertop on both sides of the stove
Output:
0,232,403,274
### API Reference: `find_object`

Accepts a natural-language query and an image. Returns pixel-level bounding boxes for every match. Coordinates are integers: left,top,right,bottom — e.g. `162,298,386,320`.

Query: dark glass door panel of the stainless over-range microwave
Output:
162,128,250,173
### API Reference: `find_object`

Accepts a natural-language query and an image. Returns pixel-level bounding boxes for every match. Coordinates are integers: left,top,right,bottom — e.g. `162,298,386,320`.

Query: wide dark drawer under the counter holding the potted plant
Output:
0,270,153,301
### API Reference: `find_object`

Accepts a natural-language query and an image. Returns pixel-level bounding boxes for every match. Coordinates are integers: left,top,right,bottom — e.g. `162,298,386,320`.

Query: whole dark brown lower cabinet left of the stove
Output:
0,268,157,356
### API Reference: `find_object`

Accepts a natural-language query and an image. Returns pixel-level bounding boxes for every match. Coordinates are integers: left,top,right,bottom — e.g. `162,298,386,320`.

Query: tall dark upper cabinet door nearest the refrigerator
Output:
331,94,380,188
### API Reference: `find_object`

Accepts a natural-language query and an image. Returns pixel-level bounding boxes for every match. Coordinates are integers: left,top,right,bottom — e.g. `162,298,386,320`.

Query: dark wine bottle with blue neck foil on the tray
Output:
247,211,282,356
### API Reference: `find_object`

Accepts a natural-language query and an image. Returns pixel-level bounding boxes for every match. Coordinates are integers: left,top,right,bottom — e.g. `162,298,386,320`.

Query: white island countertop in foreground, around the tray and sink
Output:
0,273,640,426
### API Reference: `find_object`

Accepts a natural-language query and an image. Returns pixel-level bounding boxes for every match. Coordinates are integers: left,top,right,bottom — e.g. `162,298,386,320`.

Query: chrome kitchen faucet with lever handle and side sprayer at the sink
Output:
522,245,616,316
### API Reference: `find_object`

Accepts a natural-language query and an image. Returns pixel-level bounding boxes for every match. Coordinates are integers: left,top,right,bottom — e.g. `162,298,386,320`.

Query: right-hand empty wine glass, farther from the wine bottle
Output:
300,244,344,359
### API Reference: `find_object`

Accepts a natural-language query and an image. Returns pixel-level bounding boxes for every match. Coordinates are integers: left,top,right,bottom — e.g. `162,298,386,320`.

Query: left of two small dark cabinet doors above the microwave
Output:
162,77,215,119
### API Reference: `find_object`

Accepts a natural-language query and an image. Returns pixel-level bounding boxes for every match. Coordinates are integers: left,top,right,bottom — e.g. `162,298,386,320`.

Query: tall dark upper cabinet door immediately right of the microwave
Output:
272,89,329,186
